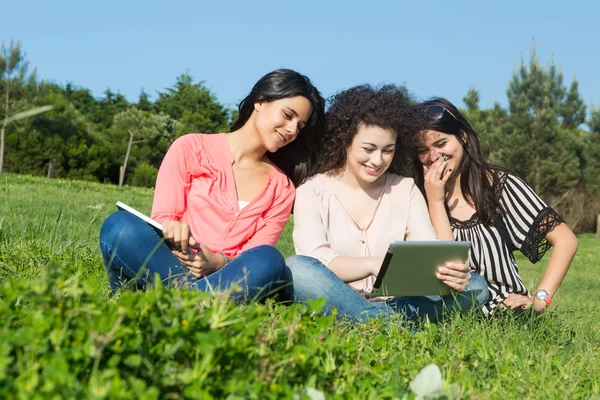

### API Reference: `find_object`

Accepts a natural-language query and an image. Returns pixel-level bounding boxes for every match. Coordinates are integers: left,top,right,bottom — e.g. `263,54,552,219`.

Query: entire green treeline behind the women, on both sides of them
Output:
0,41,600,231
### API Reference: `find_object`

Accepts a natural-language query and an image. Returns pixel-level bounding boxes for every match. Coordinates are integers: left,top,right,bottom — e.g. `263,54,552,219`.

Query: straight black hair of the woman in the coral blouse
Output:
231,69,325,186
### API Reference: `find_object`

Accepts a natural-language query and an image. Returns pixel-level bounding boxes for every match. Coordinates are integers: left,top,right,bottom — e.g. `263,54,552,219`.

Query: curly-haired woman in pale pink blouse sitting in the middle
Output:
286,85,488,321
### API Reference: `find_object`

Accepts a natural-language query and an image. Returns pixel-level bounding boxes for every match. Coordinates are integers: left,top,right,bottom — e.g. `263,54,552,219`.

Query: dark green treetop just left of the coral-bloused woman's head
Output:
154,74,229,136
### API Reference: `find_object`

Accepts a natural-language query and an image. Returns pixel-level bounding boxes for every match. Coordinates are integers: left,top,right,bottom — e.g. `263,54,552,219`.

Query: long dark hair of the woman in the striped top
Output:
412,97,507,225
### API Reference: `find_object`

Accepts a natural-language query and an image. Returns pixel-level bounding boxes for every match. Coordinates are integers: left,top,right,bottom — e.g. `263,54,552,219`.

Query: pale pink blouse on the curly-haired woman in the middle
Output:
293,174,437,294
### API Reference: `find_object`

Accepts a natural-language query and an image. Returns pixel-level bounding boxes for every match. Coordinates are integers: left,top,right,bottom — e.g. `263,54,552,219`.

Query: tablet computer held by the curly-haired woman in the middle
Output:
372,241,471,296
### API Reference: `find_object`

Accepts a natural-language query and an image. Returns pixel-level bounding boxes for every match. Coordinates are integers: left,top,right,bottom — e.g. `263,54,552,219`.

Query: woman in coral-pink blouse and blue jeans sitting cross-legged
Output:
100,69,324,299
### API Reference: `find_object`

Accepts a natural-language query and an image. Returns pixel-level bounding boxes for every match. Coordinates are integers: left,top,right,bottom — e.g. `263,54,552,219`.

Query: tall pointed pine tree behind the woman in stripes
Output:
499,44,585,194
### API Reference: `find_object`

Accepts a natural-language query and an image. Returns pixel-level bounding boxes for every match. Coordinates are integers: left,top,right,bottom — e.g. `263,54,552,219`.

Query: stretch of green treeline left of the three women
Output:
0,42,233,186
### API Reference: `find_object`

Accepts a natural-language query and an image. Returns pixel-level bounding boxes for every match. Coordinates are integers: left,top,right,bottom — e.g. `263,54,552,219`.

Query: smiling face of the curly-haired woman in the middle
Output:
345,124,398,184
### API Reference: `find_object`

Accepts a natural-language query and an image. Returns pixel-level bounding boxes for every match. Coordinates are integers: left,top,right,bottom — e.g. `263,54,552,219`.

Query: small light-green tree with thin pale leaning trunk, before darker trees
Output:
113,107,178,187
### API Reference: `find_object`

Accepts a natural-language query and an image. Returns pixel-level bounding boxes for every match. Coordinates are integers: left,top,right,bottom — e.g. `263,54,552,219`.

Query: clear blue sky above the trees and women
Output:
0,0,600,114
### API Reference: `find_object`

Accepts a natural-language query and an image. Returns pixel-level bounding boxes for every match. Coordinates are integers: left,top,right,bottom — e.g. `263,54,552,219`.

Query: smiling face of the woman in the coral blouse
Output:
254,96,312,152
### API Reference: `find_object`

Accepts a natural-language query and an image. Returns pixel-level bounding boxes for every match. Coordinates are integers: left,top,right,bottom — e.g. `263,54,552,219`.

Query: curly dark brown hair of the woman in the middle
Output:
316,85,425,175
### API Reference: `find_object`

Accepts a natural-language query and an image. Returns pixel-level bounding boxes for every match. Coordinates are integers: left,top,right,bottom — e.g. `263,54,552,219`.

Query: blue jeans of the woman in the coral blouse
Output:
100,211,292,301
